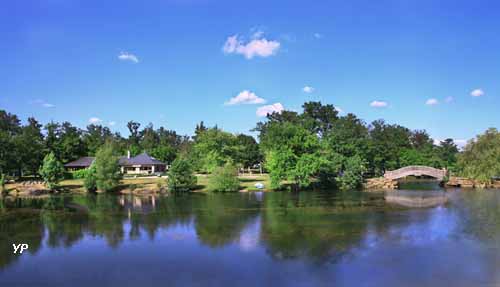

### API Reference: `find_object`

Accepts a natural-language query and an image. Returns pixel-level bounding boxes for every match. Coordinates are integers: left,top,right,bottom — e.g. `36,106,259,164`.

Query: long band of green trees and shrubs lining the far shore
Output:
0,102,500,195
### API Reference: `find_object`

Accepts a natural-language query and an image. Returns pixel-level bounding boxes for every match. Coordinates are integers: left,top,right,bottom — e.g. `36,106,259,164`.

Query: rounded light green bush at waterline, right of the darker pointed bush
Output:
208,163,240,192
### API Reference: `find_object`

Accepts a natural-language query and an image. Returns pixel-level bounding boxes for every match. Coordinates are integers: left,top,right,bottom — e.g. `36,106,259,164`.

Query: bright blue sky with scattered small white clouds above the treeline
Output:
0,0,500,146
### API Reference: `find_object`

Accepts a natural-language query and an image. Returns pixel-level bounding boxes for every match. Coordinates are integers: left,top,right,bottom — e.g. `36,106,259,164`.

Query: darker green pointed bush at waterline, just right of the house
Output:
168,158,196,192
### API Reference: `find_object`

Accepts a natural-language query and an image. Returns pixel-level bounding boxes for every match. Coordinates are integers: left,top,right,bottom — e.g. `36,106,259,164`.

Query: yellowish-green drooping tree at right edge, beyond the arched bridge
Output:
458,128,500,183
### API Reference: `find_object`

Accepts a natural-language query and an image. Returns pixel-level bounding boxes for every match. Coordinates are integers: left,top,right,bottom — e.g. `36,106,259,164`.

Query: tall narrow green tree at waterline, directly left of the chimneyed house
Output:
94,142,121,194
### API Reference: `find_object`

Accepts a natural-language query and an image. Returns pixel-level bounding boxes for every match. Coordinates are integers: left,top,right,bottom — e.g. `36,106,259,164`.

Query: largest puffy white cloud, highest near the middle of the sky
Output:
222,34,280,59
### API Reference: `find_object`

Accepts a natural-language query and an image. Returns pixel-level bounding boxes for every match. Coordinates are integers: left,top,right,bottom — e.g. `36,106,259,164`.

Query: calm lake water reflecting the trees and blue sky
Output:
0,185,500,287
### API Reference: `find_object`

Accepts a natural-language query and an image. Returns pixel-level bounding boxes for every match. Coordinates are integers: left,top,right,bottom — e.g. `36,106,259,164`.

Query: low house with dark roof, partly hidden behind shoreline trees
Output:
64,152,167,174
